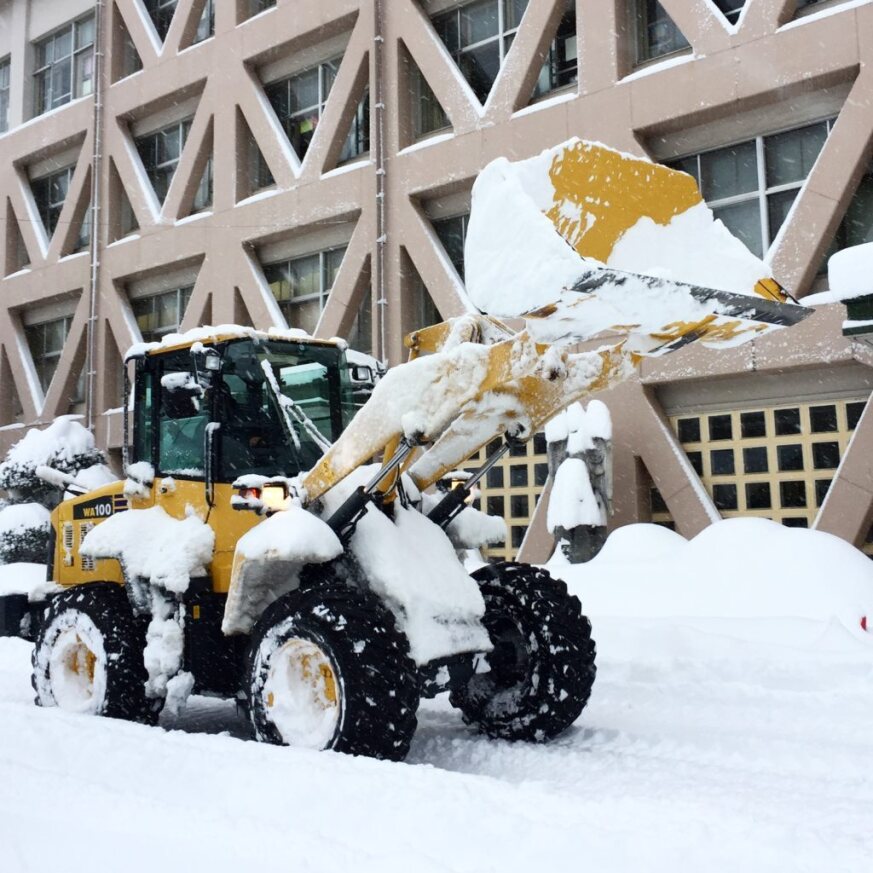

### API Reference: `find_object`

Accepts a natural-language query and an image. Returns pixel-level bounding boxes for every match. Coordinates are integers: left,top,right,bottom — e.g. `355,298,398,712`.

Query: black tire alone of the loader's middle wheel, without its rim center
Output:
246,582,420,761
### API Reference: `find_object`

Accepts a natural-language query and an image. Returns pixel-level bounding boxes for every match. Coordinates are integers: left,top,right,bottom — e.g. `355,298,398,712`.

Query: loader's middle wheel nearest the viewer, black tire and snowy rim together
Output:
247,583,419,761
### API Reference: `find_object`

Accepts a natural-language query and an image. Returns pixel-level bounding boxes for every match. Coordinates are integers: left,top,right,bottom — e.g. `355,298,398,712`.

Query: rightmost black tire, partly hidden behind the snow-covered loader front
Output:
450,563,596,742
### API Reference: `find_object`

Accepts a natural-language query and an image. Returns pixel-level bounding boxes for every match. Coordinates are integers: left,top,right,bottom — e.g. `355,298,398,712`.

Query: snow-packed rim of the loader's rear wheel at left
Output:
49,615,106,714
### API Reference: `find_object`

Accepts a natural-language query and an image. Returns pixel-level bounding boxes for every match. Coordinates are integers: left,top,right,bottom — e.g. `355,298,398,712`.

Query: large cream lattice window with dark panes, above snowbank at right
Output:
651,397,866,544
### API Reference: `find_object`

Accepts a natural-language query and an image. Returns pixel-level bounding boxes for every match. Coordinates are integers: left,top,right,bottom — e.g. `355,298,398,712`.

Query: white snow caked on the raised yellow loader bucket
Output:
464,139,769,317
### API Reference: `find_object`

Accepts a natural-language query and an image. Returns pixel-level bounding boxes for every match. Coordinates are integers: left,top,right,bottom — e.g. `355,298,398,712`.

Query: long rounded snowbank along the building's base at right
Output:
550,518,873,633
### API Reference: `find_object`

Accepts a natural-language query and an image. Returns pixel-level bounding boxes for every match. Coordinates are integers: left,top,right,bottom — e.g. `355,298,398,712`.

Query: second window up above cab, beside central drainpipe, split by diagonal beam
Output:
264,58,370,161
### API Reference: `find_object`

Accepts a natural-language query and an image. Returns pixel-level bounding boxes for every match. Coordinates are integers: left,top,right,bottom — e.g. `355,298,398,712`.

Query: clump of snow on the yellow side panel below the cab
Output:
81,506,215,594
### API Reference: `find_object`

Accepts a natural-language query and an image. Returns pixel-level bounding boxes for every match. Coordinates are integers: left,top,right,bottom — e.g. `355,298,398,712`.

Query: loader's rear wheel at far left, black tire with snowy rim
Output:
31,582,163,724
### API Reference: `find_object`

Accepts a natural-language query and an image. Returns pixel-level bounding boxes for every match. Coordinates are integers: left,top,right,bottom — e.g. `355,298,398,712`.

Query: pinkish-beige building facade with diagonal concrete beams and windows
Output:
0,0,873,558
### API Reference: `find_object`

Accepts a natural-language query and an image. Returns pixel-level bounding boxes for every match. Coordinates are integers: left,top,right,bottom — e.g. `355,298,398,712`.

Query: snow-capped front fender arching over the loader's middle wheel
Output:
221,504,343,634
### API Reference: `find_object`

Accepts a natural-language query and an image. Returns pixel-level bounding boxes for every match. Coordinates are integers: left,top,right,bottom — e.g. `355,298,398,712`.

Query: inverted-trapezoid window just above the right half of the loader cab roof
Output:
264,247,346,334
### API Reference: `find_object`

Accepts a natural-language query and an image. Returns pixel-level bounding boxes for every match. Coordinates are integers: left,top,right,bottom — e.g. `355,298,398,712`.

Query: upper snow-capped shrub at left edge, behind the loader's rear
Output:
0,415,106,507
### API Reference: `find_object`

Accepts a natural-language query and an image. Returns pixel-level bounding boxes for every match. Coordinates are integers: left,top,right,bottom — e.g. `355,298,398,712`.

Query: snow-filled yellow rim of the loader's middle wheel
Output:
263,637,341,749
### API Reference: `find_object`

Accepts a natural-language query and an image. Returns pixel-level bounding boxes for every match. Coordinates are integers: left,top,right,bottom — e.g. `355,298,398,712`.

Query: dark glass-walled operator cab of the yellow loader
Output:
130,336,359,487
